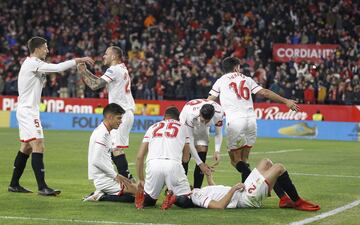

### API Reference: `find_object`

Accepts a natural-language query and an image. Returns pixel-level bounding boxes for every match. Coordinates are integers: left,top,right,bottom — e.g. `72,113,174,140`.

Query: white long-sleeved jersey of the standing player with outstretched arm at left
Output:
18,57,76,111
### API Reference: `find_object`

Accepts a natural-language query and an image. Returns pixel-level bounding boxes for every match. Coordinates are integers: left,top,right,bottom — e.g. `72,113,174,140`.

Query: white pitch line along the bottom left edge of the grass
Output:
0,216,179,225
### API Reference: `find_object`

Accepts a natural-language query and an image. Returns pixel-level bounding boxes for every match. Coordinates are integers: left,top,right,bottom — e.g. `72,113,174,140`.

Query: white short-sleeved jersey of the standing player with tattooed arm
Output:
101,63,135,111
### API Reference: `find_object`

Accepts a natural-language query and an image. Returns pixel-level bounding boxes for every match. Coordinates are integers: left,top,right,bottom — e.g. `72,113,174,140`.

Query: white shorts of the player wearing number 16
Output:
226,117,257,151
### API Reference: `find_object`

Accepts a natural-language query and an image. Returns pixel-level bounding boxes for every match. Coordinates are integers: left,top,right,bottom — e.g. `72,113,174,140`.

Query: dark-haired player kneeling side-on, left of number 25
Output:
84,103,137,202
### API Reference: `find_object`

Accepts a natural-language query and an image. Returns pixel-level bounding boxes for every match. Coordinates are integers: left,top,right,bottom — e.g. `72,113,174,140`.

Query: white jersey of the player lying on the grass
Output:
191,185,240,208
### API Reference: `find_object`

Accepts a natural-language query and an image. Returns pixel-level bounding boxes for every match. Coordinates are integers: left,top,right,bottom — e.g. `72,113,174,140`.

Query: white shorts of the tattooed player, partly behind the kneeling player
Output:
111,110,134,148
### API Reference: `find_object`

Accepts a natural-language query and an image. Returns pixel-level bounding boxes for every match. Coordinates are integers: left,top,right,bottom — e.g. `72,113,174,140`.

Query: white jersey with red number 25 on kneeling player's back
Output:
143,119,189,163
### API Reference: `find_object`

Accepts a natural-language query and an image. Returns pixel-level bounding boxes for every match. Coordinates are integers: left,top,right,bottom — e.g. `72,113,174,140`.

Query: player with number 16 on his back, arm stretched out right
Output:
208,57,299,207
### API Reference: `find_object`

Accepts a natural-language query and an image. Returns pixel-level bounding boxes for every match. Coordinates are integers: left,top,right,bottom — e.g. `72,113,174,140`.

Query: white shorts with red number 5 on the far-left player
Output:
16,107,44,143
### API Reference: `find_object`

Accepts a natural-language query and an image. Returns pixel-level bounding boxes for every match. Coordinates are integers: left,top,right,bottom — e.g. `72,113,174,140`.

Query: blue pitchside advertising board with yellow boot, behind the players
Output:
0,112,360,141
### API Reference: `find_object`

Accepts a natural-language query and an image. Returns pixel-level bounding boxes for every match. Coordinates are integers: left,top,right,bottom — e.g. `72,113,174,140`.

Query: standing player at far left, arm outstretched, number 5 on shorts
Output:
8,37,94,196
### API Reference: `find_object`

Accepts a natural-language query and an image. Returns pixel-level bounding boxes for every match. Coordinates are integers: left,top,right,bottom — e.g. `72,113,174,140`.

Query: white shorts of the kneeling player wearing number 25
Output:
144,159,191,199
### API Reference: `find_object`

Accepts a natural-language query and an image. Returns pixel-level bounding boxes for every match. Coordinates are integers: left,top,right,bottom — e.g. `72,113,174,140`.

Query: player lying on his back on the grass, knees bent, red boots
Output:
162,159,320,211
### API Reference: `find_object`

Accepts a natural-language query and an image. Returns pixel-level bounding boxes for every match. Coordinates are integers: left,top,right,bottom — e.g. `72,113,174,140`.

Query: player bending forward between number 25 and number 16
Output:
180,99,224,188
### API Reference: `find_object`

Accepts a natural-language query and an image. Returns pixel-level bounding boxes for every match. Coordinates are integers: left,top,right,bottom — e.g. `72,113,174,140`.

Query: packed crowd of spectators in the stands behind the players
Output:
0,0,360,104
